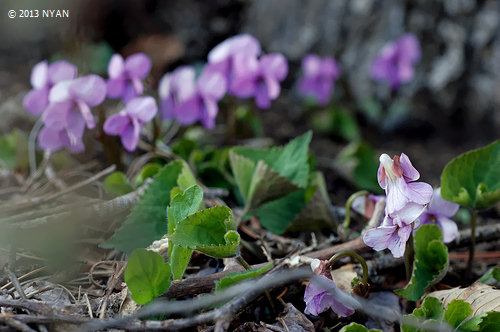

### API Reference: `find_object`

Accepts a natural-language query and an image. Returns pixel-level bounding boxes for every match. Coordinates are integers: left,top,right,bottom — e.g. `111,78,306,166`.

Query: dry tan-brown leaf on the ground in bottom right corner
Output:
427,281,500,316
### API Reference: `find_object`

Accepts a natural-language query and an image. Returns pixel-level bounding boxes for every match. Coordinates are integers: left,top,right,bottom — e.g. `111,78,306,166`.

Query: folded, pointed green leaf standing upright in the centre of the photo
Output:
229,132,311,209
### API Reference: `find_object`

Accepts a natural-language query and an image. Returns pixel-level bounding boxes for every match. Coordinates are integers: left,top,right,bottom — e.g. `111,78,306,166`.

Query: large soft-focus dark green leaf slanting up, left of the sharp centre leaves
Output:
101,161,196,253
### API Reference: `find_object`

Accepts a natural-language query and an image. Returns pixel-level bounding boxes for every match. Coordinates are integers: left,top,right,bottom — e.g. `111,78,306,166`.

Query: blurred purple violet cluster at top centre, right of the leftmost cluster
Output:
158,34,288,129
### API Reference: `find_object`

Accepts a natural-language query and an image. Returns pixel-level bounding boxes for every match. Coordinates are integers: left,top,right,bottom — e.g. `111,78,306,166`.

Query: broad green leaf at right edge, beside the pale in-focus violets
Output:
441,140,500,209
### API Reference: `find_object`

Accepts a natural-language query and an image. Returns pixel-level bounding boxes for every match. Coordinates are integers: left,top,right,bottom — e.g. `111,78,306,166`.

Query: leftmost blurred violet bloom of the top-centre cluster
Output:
158,66,196,119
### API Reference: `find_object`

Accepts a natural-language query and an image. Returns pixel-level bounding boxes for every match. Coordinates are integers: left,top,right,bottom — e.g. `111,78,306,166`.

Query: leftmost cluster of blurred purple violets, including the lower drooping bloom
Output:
23,53,156,153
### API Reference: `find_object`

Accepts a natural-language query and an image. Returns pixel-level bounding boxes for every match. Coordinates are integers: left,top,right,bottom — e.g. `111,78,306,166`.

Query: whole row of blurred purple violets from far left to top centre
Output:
23,34,288,152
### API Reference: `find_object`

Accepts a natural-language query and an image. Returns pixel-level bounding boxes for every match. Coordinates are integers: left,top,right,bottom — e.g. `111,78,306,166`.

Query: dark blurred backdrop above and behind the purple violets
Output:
0,0,500,195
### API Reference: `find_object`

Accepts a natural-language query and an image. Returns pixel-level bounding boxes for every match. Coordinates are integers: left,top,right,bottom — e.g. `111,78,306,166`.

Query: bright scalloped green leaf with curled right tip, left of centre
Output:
168,206,240,258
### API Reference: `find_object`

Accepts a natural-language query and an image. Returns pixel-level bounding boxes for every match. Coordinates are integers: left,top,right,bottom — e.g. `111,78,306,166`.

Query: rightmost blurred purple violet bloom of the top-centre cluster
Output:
231,53,288,109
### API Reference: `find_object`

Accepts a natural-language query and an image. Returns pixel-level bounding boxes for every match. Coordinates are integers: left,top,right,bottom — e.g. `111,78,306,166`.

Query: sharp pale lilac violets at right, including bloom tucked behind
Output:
363,153,459,258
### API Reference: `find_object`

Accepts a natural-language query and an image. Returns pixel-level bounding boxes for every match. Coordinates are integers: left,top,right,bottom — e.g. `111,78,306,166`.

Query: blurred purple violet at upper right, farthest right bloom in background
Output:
371,33,420,90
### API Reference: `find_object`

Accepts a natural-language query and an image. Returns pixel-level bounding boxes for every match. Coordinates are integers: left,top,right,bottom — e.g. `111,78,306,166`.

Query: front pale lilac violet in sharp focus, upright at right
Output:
363,153,433,257
